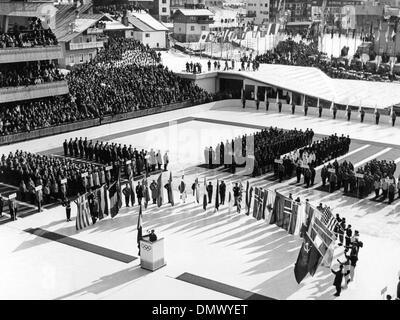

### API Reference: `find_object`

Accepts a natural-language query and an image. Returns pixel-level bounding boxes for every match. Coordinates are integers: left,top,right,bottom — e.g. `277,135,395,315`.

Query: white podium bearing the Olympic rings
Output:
140,238,166,271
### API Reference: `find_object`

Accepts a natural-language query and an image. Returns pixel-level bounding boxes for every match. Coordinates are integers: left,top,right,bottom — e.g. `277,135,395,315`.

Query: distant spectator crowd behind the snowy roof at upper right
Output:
254,39,397,81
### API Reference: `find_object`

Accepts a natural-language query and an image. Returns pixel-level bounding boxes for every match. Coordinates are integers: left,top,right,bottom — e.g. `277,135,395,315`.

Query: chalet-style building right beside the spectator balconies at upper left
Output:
54,3,111,68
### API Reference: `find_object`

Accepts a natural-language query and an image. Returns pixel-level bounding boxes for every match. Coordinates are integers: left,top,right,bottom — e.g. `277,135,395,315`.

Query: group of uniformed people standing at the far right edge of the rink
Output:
321,159,400,204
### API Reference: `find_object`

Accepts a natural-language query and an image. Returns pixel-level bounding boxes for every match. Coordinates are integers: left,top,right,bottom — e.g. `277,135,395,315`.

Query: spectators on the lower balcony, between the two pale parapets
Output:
0,61,64,88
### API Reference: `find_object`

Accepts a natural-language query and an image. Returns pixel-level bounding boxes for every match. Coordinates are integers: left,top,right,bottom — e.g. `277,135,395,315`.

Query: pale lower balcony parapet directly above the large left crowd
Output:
0,80,69,103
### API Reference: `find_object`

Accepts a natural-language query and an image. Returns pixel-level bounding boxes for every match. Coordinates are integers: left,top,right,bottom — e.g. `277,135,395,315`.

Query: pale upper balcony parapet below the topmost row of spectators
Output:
0,45,62,64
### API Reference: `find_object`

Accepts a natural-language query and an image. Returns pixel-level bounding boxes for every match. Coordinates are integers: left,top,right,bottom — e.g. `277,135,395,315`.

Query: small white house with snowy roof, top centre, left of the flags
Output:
172,9,214,42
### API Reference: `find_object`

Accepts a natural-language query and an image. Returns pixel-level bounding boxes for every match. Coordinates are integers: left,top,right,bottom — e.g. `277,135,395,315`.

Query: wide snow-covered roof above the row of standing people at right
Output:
225,64,400,109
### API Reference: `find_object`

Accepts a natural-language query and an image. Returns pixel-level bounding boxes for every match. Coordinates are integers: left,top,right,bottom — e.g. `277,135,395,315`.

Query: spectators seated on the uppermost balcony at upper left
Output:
0,18,58,49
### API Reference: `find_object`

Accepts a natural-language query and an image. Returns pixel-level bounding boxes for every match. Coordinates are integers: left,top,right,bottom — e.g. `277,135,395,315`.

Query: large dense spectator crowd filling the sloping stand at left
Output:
0,38,213,135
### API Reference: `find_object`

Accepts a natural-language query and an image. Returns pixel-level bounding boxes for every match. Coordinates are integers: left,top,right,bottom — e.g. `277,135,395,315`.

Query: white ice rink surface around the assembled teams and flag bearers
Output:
0,102,400,300
